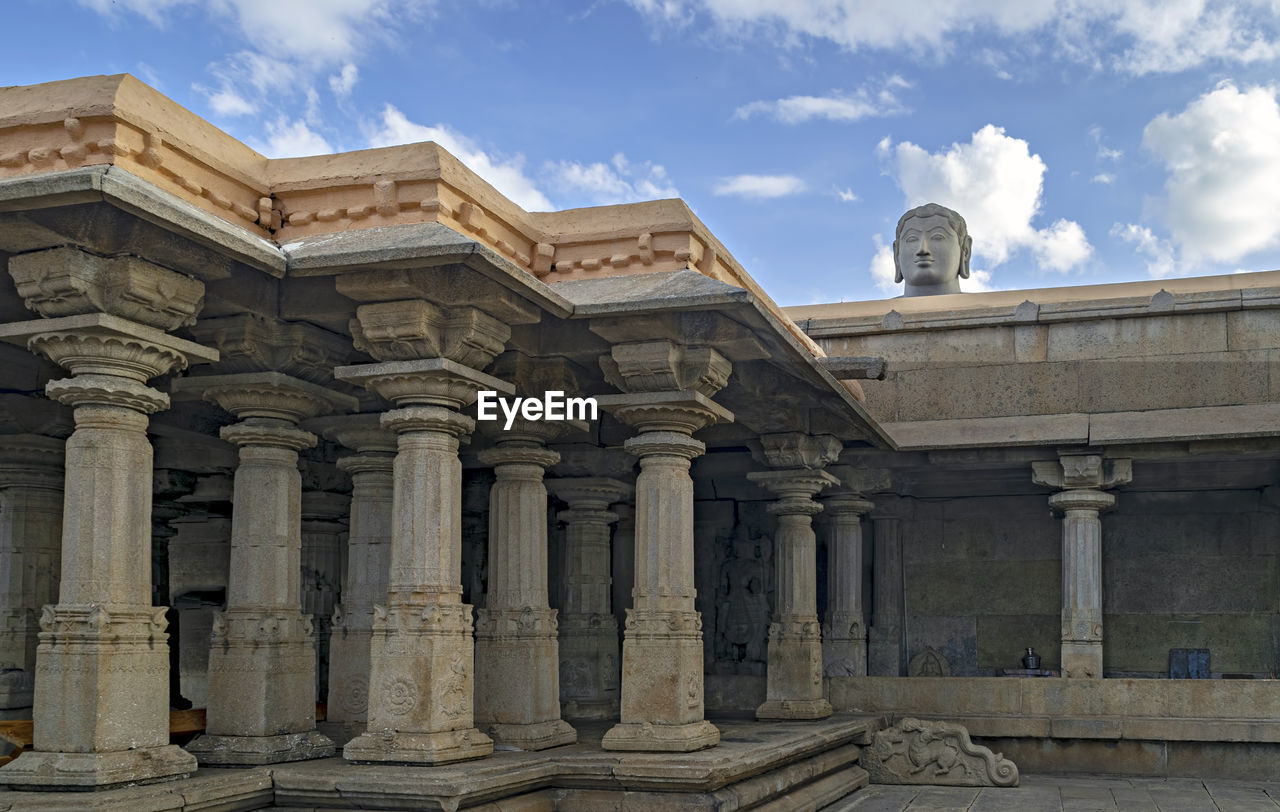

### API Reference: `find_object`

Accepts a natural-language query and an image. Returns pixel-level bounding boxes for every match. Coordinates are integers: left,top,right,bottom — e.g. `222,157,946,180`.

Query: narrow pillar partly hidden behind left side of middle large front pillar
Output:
317,415,396,743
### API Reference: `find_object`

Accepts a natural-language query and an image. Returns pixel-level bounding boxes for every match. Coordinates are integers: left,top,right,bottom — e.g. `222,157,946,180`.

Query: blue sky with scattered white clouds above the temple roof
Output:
0,0,1280,305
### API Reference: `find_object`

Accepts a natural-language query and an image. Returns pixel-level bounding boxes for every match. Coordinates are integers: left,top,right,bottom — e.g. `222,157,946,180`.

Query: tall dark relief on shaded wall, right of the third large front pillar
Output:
712,523,773,675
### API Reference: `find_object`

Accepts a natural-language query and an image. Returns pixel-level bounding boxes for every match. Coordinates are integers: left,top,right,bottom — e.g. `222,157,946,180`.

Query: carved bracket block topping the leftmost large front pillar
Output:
9,247,205,330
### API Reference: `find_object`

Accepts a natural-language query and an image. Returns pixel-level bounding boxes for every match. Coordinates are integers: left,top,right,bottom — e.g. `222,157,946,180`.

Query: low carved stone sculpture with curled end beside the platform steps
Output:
858,717,1018,786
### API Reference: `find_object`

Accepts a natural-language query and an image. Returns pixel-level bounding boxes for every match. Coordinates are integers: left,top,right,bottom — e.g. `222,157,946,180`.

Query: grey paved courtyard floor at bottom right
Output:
823,775,1280,812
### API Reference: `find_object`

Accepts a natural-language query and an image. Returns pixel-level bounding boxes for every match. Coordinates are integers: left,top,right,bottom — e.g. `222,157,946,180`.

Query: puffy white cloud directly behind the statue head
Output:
877,124,1093,272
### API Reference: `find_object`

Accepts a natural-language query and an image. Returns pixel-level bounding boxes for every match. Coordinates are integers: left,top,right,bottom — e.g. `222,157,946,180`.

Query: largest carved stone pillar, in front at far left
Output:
0,248,218,788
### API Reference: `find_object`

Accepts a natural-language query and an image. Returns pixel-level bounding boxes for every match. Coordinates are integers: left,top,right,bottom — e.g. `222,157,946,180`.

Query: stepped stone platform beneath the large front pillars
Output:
0,715,878,812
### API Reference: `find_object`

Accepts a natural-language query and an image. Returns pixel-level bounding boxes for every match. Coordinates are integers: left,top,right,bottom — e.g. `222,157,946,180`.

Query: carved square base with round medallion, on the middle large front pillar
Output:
342,603,493,765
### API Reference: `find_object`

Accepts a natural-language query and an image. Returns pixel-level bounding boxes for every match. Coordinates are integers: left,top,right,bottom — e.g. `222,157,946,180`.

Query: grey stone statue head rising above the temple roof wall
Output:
893,204,973,296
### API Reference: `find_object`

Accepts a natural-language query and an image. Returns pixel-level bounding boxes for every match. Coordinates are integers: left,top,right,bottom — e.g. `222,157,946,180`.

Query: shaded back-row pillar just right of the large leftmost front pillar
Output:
182,371,357,765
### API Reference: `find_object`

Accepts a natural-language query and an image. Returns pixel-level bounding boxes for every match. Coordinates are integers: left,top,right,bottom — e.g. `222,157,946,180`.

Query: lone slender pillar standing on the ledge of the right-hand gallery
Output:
1032,453,1133,679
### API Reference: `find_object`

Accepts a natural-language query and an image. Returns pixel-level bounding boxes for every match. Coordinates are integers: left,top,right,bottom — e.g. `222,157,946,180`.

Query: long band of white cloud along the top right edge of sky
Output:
628,0,1280,76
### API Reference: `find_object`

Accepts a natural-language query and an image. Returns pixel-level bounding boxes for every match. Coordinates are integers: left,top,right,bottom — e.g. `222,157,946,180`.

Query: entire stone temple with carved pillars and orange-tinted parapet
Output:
0,76,1280,811
